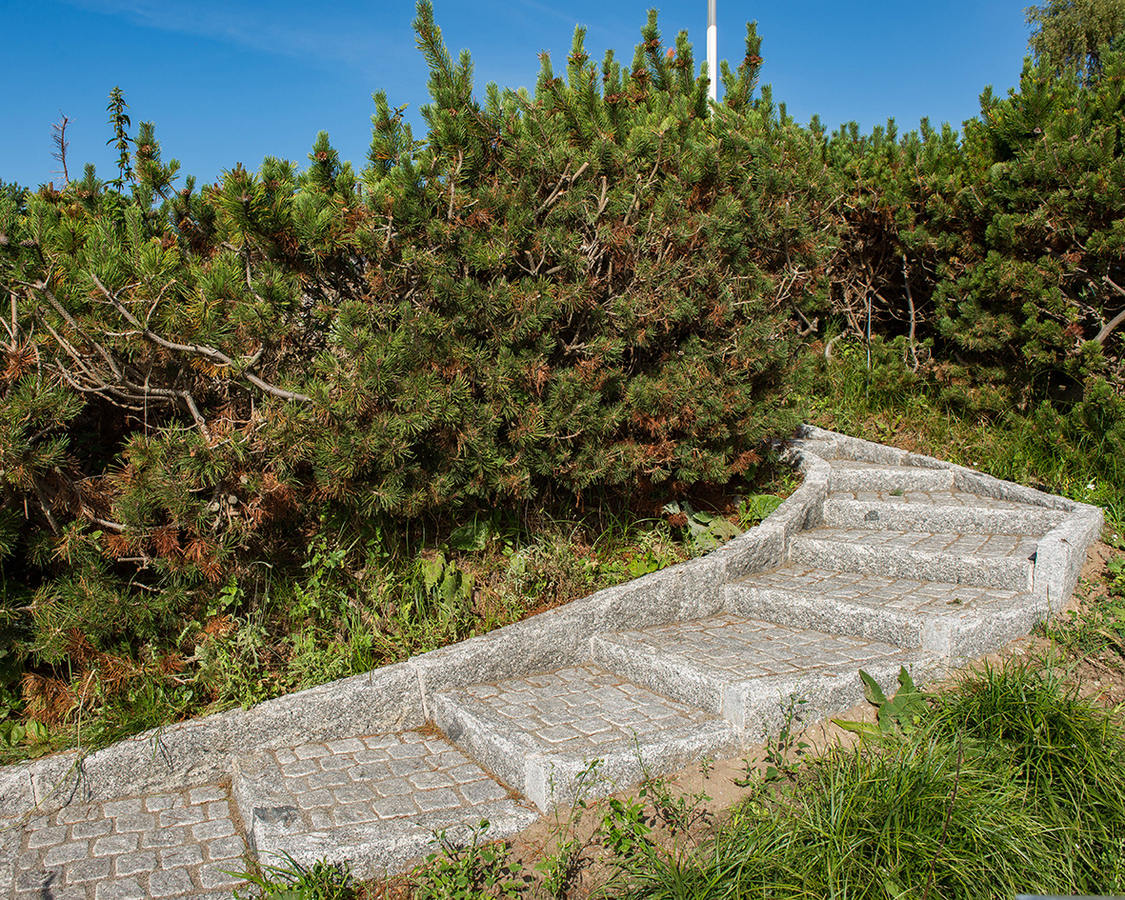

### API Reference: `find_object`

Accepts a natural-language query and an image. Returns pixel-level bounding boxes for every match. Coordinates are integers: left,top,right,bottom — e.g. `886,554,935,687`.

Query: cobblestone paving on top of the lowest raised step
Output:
265,731,509,829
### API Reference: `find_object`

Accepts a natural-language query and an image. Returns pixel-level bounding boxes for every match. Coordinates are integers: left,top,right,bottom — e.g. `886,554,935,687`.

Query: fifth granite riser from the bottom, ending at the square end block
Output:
790,538,1032,592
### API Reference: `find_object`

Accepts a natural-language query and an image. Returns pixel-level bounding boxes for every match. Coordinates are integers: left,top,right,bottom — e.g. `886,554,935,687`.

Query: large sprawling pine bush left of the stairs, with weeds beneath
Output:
0,3,824,738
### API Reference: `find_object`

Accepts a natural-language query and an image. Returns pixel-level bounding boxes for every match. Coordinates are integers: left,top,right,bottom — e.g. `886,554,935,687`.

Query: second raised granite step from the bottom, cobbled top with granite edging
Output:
431,665,739,812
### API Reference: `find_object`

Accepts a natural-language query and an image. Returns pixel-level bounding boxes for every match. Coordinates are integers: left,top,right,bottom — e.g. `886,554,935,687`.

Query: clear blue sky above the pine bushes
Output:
0,0,1028,187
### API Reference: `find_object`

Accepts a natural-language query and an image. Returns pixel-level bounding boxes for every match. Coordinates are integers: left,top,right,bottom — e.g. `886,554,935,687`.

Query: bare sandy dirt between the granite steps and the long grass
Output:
362,541,1125,900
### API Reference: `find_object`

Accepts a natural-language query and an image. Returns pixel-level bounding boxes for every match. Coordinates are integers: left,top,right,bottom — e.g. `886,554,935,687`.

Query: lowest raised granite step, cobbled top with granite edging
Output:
232,731,539,878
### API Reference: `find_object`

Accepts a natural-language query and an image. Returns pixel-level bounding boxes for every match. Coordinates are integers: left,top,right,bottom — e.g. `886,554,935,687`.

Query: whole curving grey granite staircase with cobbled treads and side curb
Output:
0,428,1103,900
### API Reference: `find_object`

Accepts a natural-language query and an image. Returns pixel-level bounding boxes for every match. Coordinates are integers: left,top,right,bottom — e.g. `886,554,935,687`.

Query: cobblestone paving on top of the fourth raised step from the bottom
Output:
746,566,1019,617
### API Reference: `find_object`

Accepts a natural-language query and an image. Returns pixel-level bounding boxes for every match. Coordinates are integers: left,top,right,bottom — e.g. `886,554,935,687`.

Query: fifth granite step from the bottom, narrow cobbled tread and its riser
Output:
789,528,1037,593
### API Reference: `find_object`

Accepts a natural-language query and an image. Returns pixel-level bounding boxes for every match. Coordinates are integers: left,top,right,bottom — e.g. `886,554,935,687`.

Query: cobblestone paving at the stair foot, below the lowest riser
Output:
5,785,246,900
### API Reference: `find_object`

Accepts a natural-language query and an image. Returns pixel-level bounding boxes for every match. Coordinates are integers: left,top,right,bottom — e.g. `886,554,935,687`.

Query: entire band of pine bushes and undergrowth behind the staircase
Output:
0,0,1125,765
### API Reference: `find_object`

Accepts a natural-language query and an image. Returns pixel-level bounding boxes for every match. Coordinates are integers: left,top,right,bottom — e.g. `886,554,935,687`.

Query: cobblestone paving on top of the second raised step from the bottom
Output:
452,666,716,758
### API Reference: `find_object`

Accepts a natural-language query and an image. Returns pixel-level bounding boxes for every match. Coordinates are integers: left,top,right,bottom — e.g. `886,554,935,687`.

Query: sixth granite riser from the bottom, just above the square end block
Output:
825,497,1062,534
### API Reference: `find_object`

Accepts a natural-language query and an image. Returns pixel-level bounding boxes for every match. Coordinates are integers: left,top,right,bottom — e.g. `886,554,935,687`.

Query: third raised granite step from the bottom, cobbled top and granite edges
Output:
593,613,915,743
